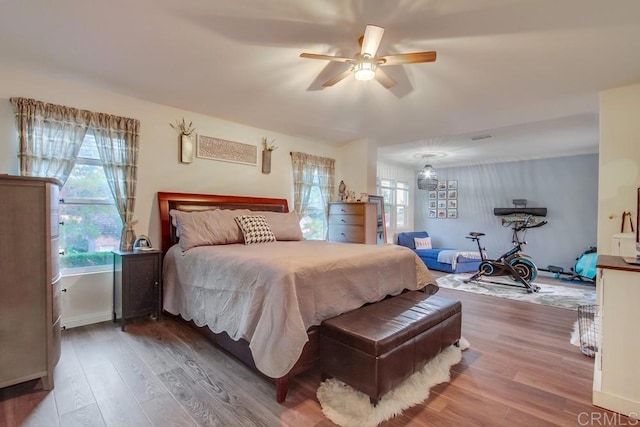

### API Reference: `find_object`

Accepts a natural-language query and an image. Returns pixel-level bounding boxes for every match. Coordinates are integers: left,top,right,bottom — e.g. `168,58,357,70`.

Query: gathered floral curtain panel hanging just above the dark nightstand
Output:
91,113,140,250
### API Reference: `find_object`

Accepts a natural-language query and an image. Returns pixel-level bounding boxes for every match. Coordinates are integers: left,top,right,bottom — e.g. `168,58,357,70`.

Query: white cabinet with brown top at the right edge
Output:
593,255,640,418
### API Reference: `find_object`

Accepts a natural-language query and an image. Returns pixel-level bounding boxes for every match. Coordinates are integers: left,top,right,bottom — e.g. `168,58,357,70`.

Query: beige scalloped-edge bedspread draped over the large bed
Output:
163,240,436,378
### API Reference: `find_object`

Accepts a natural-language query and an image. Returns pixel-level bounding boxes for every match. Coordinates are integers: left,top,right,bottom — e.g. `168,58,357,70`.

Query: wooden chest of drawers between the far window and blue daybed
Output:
329,202,378,245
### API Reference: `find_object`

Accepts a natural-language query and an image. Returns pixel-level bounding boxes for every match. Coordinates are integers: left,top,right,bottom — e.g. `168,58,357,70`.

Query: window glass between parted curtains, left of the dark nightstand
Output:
60,134,122,273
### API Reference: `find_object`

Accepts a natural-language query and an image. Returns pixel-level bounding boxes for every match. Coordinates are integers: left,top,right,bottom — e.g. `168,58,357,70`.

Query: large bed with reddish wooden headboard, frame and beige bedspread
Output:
158,192,437,403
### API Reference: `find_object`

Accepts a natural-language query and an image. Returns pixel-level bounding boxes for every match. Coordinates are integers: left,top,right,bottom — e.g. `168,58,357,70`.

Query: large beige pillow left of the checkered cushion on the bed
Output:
169,209,251,251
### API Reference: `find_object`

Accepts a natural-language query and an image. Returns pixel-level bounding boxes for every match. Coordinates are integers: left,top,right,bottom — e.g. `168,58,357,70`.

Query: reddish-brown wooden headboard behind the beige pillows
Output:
158,192,289,253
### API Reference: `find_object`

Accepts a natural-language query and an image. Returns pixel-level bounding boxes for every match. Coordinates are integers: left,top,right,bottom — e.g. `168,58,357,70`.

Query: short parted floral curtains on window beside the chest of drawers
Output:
291,152,336,237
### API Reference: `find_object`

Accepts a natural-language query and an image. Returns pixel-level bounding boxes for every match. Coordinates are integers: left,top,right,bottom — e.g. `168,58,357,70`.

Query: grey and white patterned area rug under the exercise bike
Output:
436,274,596,310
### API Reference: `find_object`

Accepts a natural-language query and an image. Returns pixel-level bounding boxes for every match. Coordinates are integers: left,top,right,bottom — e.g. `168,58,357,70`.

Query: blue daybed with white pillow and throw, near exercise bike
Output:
398,231,481,273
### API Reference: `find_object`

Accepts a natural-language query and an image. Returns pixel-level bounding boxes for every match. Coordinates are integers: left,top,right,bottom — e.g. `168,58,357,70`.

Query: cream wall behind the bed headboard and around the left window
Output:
0,67,352,326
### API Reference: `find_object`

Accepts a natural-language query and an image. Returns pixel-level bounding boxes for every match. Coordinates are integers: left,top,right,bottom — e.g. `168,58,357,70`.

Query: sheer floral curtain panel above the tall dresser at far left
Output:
10,98,91,184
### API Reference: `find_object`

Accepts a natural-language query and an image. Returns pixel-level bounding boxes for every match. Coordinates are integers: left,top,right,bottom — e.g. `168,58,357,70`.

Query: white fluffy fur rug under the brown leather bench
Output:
316,338,469,427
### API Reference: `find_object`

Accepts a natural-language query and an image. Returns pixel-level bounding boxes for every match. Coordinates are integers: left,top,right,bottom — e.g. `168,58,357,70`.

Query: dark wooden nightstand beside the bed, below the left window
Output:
113,249,162,331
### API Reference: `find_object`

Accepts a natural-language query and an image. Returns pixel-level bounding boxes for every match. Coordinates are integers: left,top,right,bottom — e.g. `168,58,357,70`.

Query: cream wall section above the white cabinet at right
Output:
598,84,640,254
